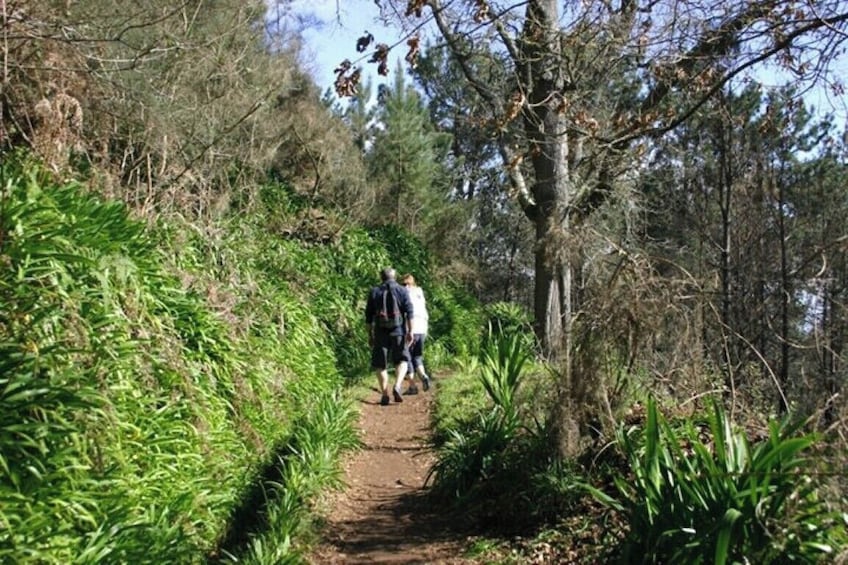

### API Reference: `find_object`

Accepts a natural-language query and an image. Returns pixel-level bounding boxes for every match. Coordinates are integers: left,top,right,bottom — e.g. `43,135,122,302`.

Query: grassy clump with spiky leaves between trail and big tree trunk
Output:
428,326,576,533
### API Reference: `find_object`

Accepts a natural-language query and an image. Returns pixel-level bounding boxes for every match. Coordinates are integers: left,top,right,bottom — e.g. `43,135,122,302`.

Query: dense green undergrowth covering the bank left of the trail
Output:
0,159,474,563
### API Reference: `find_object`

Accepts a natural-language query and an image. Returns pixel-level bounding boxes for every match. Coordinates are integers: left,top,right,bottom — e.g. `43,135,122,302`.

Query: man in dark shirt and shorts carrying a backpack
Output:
365,267,413,406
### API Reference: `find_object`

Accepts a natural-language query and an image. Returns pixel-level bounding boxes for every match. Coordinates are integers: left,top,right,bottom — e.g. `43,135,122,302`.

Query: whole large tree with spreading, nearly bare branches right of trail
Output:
334,0,848,449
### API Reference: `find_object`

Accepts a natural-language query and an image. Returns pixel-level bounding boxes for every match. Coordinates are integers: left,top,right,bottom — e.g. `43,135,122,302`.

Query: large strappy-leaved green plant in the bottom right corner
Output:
591,400,845,564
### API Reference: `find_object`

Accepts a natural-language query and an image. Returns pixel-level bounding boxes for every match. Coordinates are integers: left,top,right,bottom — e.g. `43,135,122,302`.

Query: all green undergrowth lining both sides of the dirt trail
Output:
0,152,846,563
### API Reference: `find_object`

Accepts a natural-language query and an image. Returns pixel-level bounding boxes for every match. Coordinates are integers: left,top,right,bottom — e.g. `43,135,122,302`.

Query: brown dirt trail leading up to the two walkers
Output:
309,387,475,565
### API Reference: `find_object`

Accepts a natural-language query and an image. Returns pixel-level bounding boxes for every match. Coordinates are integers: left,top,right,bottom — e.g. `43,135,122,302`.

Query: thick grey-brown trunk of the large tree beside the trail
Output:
520,0,589,457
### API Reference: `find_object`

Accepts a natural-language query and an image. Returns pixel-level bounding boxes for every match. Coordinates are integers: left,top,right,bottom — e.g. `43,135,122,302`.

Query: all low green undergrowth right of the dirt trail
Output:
429,324,848,564
